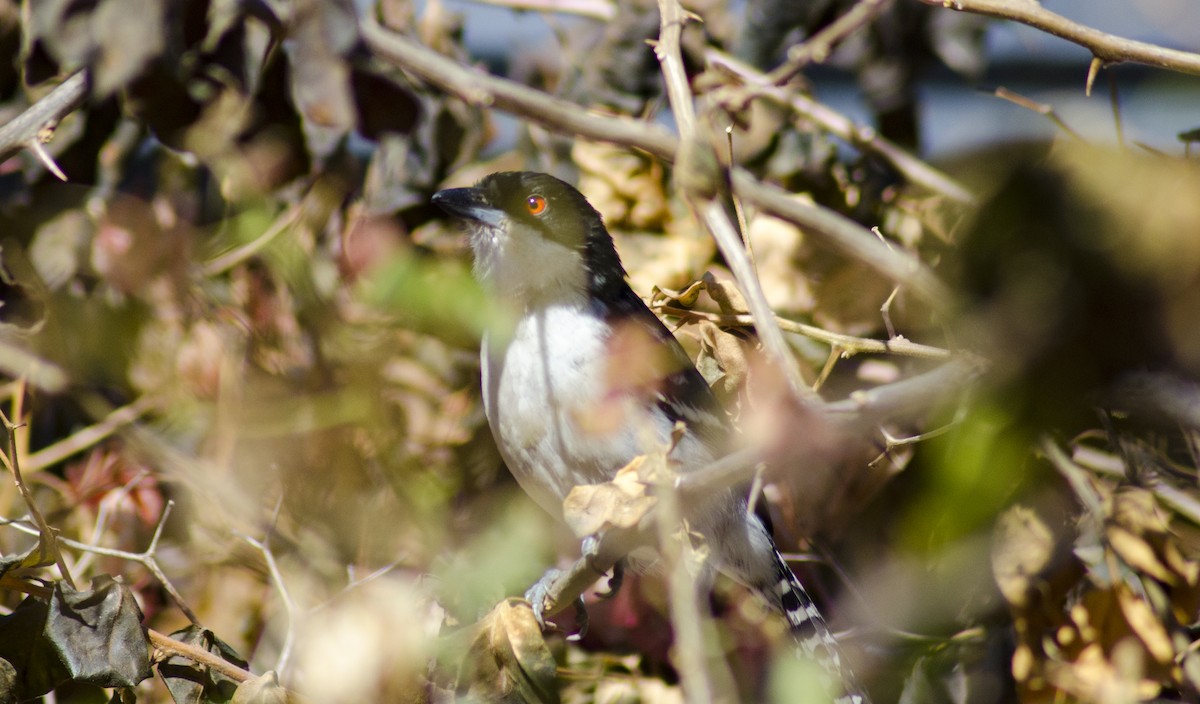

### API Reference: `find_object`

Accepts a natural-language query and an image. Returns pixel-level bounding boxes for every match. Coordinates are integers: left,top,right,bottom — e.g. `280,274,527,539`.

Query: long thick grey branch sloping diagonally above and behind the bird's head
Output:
361,16,948,306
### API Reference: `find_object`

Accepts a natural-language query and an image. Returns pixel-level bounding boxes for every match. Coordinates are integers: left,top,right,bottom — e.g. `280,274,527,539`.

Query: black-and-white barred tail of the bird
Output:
763,552,870,704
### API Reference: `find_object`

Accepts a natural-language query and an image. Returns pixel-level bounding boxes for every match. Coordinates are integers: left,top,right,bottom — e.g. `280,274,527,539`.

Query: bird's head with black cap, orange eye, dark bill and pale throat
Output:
433,172,626,305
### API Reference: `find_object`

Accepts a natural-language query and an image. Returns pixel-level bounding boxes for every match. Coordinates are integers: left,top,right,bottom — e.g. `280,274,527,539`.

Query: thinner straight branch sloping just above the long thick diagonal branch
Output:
704,48,974,204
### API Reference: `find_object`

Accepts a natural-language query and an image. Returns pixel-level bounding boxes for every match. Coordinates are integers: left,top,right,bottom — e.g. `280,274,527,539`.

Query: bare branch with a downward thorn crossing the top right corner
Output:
918,0,1200,76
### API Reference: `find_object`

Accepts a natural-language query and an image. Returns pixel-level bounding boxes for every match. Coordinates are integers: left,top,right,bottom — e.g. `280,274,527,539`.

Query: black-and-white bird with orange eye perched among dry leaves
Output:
432,172,869,704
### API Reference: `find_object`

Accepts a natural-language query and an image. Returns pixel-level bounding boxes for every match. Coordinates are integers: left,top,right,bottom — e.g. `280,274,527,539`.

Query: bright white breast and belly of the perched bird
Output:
482,305,715,516
